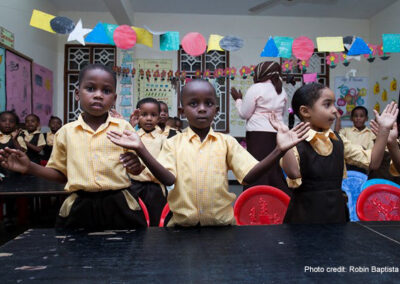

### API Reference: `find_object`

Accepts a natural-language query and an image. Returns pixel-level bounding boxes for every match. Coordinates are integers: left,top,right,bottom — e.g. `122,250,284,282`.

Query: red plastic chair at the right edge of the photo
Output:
356,184,400,221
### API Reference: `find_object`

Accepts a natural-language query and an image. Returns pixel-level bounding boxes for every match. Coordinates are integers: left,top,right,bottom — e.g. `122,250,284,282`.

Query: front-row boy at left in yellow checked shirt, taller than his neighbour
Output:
0,64,146,230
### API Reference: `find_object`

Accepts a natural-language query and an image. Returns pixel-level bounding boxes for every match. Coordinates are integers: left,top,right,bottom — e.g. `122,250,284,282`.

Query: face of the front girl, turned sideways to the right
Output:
307,88,337,131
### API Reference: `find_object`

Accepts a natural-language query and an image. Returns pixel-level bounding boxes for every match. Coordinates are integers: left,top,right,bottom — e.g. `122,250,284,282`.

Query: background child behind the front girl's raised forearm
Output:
335,106,375,173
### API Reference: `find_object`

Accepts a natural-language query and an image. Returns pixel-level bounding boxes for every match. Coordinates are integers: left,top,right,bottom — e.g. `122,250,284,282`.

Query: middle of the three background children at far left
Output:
20,113,46,164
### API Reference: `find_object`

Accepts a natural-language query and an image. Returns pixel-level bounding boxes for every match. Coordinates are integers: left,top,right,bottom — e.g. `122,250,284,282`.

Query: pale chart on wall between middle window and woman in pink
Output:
229,76,253,136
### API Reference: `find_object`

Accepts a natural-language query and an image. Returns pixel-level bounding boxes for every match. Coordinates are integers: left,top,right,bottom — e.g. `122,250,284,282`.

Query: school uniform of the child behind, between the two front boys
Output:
130,126,167,226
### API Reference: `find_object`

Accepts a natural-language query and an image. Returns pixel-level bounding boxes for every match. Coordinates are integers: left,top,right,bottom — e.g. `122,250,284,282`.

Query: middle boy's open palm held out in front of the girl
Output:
269,113,310,152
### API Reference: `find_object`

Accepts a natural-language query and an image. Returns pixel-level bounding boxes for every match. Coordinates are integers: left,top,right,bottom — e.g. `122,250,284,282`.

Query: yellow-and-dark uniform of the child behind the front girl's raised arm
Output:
339,126,376,174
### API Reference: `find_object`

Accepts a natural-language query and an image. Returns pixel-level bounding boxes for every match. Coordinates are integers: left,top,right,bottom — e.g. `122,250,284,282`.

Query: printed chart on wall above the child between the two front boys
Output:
135,59,174,110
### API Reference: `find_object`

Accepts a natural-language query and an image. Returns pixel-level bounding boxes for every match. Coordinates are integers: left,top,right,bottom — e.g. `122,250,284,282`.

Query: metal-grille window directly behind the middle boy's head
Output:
178,47,229,133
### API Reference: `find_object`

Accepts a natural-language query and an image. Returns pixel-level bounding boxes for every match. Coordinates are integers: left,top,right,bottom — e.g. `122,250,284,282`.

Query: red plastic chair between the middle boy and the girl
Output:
233,185,290,225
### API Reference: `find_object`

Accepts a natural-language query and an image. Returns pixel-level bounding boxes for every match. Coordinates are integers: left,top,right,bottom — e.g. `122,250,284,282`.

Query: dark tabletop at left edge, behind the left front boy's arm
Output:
0,174,66,196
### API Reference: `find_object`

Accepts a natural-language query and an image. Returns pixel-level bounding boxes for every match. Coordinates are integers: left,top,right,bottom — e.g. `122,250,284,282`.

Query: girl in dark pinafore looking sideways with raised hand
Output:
283,83,398,224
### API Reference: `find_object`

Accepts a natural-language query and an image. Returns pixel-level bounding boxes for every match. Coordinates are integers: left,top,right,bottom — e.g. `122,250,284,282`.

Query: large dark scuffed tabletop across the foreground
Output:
0,222,400,283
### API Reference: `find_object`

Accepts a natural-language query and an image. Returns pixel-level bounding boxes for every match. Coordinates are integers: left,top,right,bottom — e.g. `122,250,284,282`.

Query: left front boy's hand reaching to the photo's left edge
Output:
0,147,31,174
